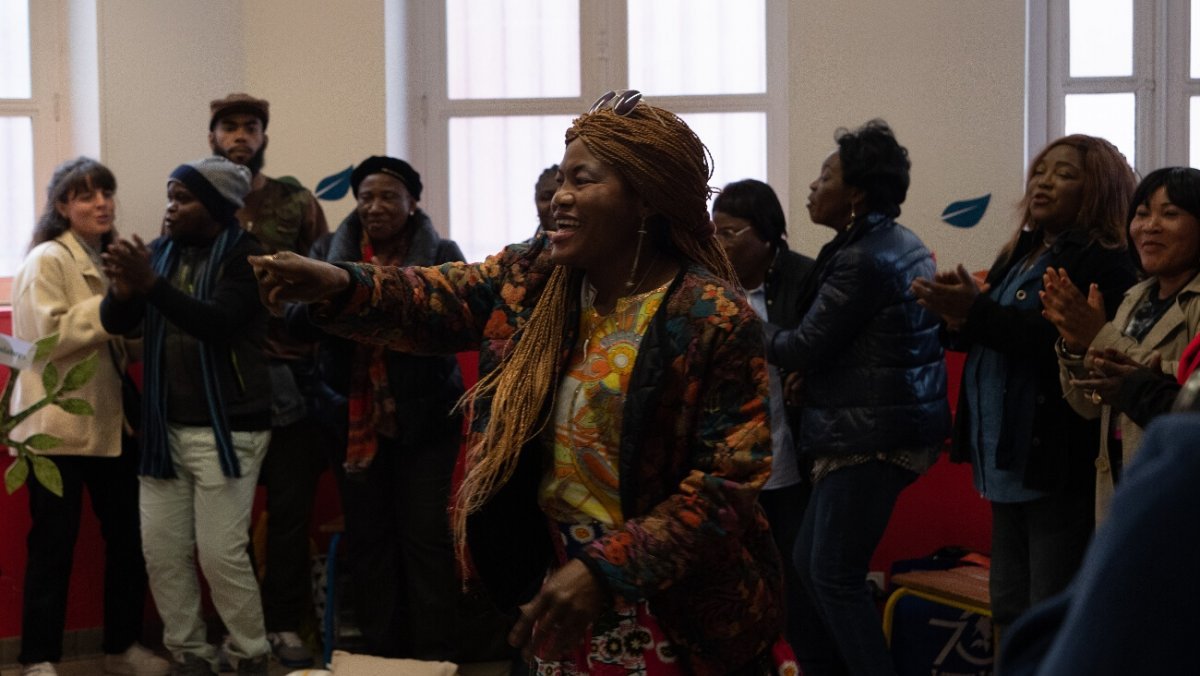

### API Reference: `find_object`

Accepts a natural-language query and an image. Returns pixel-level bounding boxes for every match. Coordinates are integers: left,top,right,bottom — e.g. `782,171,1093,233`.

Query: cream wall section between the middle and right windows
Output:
788,0,1025,270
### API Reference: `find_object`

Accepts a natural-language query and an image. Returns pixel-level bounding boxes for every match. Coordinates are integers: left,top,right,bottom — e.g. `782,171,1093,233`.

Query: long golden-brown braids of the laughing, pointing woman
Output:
454,101,737,560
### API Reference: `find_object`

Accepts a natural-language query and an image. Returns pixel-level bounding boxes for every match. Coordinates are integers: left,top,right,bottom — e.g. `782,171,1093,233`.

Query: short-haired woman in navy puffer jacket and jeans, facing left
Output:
767,120,949,676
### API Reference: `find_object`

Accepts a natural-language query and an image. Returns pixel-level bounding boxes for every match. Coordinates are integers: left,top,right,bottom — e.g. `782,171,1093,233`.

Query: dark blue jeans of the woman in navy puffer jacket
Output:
793,460,917,676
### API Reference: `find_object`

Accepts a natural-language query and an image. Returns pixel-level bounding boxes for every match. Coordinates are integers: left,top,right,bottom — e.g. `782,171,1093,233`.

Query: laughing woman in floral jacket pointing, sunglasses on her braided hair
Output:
253,91,782,674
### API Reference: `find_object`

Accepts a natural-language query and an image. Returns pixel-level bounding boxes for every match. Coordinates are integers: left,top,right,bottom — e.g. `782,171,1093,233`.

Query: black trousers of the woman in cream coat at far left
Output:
17,448,146,664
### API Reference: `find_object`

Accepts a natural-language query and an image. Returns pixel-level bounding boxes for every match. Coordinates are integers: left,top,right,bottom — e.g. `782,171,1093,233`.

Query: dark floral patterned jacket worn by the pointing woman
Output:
313,238,782,674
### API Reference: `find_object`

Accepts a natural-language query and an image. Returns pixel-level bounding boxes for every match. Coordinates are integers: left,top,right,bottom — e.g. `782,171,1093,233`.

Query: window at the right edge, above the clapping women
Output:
1027,0,1200,174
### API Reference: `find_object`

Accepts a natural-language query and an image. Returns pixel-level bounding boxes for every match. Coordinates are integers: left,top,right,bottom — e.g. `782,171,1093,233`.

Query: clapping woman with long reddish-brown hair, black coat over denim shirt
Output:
912,134,1136,628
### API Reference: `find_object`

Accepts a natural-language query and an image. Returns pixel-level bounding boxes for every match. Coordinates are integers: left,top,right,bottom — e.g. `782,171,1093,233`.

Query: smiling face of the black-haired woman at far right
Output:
1129,187,1200,289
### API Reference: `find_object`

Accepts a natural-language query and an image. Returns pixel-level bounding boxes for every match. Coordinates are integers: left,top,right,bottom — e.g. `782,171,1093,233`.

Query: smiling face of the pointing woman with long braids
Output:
550,139,643,276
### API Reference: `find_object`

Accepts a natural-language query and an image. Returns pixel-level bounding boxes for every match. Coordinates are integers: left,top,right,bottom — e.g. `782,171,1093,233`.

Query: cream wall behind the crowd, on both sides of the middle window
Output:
87,0,1025,269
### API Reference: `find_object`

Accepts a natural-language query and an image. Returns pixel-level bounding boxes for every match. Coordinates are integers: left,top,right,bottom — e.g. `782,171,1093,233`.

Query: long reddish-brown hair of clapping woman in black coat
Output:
1001,133,1138,264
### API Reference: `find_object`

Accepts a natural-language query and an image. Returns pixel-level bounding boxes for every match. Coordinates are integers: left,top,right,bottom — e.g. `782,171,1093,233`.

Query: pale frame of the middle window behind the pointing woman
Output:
405,0,790,252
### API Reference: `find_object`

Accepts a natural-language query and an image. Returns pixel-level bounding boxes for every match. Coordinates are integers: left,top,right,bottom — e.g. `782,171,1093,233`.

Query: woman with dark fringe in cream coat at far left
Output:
12,157,170,676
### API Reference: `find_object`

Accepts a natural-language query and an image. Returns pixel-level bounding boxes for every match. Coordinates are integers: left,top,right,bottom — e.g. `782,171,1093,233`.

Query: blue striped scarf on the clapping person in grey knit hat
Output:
139,225,244,479
